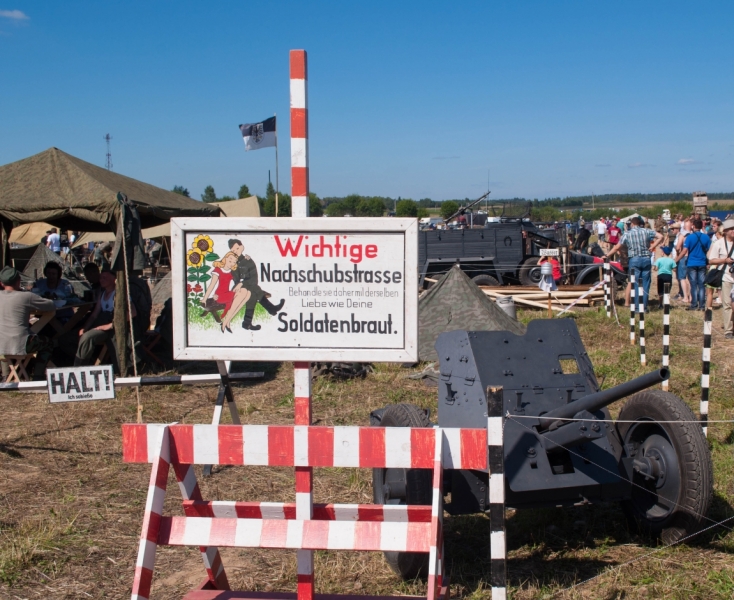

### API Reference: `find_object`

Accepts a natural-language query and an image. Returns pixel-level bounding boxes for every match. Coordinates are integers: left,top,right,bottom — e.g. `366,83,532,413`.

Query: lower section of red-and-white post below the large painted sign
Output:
291,364,314,600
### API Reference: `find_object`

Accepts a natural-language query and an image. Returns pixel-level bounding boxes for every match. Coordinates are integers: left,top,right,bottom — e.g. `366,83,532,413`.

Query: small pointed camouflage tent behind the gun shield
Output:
418,266,525,361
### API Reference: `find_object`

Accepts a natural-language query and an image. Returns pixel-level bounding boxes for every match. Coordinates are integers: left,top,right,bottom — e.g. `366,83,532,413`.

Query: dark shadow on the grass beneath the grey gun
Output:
444,494,734,597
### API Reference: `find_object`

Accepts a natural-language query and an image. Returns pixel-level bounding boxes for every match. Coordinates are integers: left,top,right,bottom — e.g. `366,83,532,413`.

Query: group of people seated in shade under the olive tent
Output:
0,262,152,379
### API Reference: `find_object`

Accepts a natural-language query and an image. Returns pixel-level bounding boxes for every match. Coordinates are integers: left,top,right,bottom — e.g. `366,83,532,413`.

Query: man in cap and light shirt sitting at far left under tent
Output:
0,267,56,380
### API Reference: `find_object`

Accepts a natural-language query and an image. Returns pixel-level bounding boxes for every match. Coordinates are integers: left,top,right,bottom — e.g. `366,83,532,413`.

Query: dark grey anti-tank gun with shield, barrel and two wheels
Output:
372,319,713,577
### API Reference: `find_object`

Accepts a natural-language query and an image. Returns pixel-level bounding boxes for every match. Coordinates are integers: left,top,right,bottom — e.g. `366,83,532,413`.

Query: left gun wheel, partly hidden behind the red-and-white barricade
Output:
372,404,433,579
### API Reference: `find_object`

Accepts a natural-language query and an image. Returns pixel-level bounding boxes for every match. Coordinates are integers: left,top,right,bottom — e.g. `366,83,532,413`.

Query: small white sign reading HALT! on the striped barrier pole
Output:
46,365,115,402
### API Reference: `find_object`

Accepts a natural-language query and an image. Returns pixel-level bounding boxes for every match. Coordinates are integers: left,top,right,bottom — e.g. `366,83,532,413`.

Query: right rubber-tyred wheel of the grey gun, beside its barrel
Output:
617,390,713,544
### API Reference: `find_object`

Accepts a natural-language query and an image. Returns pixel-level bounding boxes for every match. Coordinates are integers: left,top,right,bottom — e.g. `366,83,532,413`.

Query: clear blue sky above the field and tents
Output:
0,0,734,199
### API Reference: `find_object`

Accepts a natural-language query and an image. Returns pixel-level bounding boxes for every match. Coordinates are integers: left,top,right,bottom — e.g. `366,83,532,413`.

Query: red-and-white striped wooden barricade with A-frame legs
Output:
122,424,494,600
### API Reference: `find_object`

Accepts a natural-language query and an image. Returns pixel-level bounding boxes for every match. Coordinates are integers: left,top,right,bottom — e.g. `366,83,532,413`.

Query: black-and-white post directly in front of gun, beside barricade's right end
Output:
487,387,507,600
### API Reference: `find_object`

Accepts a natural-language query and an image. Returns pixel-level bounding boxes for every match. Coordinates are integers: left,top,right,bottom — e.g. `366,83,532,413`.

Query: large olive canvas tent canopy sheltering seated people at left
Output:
0,148,220,373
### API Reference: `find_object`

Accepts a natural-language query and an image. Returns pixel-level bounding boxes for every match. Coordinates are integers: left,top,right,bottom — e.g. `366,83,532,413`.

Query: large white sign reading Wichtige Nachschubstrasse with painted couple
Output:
171,218,418,362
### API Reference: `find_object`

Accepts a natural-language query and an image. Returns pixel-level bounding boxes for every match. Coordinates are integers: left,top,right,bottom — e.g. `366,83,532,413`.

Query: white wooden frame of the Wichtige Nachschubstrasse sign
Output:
171,217,418,362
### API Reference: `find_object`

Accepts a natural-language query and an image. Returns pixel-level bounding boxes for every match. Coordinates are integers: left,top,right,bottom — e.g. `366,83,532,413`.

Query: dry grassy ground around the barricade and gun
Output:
0,308,734,600
